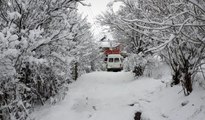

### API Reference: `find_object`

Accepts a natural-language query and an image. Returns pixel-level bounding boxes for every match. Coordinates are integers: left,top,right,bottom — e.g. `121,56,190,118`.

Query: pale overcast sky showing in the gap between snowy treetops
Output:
78,0,119,39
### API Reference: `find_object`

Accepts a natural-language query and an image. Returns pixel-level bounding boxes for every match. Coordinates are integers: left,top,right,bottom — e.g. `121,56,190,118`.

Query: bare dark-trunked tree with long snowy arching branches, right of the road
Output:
120,0,205,95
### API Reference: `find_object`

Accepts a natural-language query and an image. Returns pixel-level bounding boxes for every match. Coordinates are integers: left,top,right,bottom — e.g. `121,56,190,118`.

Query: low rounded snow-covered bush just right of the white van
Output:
124,54,165,79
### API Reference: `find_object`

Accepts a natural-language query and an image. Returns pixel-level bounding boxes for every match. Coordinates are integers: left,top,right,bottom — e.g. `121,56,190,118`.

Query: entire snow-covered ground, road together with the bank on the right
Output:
33,68,205,120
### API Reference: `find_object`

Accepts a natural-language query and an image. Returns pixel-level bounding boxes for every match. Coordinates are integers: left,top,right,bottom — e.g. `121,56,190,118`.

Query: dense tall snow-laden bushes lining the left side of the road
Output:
0,0,92,120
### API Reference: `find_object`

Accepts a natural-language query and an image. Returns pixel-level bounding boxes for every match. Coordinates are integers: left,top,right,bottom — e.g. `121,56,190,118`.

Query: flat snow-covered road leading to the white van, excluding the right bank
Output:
36,72,162,120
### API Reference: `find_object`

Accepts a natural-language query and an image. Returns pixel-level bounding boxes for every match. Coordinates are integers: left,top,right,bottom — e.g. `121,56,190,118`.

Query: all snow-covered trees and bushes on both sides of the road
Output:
0,0,205,120
